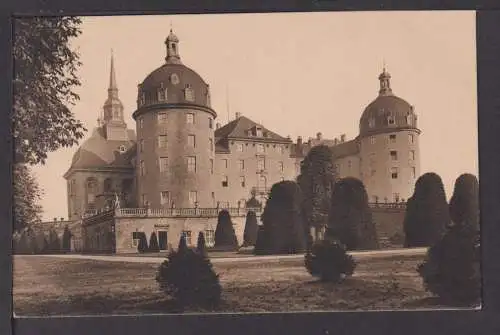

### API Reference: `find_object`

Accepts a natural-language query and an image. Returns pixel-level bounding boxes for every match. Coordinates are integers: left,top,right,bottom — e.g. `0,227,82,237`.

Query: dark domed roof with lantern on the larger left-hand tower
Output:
134,30,215,117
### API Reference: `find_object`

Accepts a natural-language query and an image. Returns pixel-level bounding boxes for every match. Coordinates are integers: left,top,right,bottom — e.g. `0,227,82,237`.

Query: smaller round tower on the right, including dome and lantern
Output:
358,67,420,202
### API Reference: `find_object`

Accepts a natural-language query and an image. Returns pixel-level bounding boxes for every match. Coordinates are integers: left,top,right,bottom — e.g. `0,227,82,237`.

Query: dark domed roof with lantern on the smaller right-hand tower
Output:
359,67,418,137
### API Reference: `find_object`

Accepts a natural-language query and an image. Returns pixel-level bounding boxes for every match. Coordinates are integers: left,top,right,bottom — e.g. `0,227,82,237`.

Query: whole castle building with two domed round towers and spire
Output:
64,30,420,253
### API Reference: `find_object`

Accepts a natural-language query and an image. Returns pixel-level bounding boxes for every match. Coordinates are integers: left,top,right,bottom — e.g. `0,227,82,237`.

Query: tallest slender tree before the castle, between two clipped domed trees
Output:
297,145,336,238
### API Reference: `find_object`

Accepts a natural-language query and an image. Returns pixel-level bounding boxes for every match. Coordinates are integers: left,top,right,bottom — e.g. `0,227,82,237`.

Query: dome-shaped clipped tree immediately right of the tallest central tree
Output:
328,177,379,250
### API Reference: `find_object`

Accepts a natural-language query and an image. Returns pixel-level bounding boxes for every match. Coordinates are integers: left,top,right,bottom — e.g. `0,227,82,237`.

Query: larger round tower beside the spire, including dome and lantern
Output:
133,30,217,208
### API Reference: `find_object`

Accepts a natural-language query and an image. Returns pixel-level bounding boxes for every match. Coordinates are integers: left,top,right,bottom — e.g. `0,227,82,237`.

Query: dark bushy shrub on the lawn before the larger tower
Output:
156,236,222,308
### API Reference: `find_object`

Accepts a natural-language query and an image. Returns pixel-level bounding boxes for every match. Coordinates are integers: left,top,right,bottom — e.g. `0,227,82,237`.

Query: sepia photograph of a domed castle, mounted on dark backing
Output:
12,11,482,318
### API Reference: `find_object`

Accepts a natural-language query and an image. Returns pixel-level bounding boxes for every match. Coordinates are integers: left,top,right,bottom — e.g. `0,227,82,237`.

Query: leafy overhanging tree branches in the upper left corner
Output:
12,16,86,164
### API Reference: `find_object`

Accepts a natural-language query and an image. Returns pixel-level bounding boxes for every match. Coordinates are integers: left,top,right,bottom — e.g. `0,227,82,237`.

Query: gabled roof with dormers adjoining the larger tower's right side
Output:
215,116,292,143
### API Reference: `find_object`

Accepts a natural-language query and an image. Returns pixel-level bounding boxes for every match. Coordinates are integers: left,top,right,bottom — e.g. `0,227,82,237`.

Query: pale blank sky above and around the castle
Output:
29,11,478,220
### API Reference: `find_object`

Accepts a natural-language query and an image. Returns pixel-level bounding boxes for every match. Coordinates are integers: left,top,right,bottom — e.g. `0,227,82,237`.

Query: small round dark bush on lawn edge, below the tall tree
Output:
305,238,356,283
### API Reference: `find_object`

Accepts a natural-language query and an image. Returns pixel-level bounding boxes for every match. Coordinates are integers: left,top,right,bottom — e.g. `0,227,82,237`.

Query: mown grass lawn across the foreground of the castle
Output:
14,256,458,316
